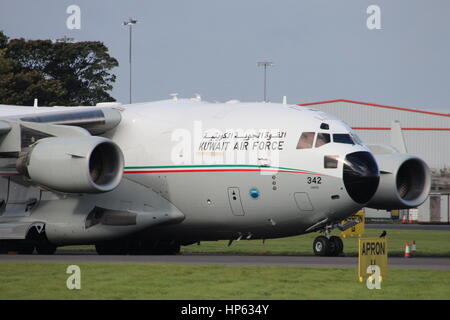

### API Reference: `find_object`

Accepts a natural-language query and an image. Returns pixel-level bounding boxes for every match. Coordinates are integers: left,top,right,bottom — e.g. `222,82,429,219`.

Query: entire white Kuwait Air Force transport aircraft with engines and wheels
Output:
0,97,430,255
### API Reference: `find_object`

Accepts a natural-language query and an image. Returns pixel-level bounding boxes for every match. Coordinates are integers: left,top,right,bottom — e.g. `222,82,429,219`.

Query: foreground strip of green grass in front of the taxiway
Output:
0,262,450,299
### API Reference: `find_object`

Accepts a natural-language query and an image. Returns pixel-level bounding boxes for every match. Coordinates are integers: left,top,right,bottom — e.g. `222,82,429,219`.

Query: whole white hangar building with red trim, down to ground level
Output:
300,99,450,223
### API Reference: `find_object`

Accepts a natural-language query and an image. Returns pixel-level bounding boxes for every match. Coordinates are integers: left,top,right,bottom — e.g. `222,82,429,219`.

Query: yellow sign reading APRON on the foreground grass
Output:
358,238,388,282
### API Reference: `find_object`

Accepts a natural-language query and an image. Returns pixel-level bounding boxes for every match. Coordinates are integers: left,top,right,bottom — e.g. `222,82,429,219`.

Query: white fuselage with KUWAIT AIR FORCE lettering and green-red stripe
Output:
3,100,369,242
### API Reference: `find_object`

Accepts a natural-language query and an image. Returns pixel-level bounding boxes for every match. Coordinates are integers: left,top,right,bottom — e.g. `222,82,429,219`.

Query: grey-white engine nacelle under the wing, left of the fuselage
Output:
16,136,124,193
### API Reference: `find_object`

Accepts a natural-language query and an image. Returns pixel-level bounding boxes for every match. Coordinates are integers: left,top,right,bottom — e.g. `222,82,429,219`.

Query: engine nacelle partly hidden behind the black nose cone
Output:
367,153,431,209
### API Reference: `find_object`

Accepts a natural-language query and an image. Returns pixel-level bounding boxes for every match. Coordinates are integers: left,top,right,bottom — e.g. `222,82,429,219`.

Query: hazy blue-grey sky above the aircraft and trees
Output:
0,0,450,113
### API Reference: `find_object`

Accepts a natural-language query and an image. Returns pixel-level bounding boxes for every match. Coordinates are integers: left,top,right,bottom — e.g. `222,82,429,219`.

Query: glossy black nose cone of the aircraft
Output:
343,151,380,204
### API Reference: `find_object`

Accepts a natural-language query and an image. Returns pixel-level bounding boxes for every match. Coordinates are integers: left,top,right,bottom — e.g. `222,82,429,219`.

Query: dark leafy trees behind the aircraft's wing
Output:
0,30,119,106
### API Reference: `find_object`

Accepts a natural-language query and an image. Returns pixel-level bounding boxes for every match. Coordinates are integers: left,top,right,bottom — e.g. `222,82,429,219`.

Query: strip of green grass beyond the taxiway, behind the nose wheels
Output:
61,229,450,257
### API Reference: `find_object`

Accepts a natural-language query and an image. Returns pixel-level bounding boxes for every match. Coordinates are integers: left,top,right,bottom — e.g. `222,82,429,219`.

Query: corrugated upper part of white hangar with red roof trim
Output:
299,99,450,169
